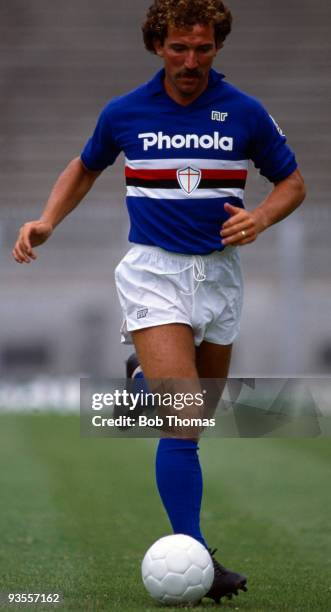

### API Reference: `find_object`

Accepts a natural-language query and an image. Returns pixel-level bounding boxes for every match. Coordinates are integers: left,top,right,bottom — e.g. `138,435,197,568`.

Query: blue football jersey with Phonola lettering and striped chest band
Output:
81,70,297,254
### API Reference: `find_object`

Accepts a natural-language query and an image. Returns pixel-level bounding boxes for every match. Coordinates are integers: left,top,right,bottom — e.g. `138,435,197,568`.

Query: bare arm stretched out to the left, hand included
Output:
13,157,101,263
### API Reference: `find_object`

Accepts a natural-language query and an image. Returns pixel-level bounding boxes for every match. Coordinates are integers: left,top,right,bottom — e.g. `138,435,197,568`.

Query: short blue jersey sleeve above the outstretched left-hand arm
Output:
81,105,121,171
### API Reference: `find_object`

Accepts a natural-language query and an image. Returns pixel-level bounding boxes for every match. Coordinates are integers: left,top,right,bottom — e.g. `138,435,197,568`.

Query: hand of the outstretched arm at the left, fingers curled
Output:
12,221,53,263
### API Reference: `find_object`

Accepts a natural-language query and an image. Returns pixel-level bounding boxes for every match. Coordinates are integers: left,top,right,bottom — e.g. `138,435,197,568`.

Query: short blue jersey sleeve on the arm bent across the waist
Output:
250,102,297,183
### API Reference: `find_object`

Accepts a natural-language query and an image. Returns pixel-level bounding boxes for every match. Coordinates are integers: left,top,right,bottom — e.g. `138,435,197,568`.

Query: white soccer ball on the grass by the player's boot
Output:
141,534,214,605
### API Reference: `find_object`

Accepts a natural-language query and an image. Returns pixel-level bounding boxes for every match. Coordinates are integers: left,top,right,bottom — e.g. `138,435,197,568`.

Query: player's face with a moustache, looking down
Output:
155,24,218,104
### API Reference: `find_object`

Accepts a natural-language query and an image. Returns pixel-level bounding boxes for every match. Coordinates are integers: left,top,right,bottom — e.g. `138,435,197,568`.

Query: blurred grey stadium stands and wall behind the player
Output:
0,0,331,400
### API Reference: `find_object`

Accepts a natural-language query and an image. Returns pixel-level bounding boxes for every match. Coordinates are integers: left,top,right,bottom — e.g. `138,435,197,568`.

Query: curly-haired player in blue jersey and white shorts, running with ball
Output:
13,0,305,602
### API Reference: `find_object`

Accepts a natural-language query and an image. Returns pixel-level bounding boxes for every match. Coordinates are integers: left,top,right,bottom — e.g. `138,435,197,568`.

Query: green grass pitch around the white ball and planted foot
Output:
0,414,331,612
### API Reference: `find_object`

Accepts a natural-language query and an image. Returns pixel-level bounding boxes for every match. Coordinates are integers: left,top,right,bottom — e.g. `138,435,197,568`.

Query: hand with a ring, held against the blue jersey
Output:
220,203,264,246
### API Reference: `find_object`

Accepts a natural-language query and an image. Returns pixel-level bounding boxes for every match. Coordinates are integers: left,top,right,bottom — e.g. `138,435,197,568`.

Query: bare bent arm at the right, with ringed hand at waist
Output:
221,170,306,246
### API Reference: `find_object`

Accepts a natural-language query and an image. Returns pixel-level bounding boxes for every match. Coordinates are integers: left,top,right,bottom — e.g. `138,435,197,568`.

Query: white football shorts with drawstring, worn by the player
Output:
115,244,243,346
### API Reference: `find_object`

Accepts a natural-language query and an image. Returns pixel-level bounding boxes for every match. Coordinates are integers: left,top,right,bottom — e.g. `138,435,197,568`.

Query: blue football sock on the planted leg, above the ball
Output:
156,438,207,548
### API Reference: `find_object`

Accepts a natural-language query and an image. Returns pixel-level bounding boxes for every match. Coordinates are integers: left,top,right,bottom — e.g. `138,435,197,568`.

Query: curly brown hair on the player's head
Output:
142,0,232,53
